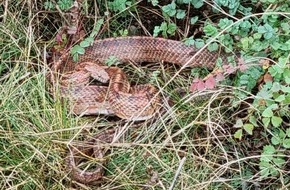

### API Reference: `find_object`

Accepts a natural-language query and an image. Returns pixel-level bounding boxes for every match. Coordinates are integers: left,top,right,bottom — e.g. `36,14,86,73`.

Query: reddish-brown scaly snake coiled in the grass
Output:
53,37,232,183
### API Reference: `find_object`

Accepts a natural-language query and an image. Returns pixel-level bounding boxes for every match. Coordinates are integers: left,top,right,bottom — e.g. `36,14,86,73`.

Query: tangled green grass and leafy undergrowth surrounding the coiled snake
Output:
0,0,290,189
